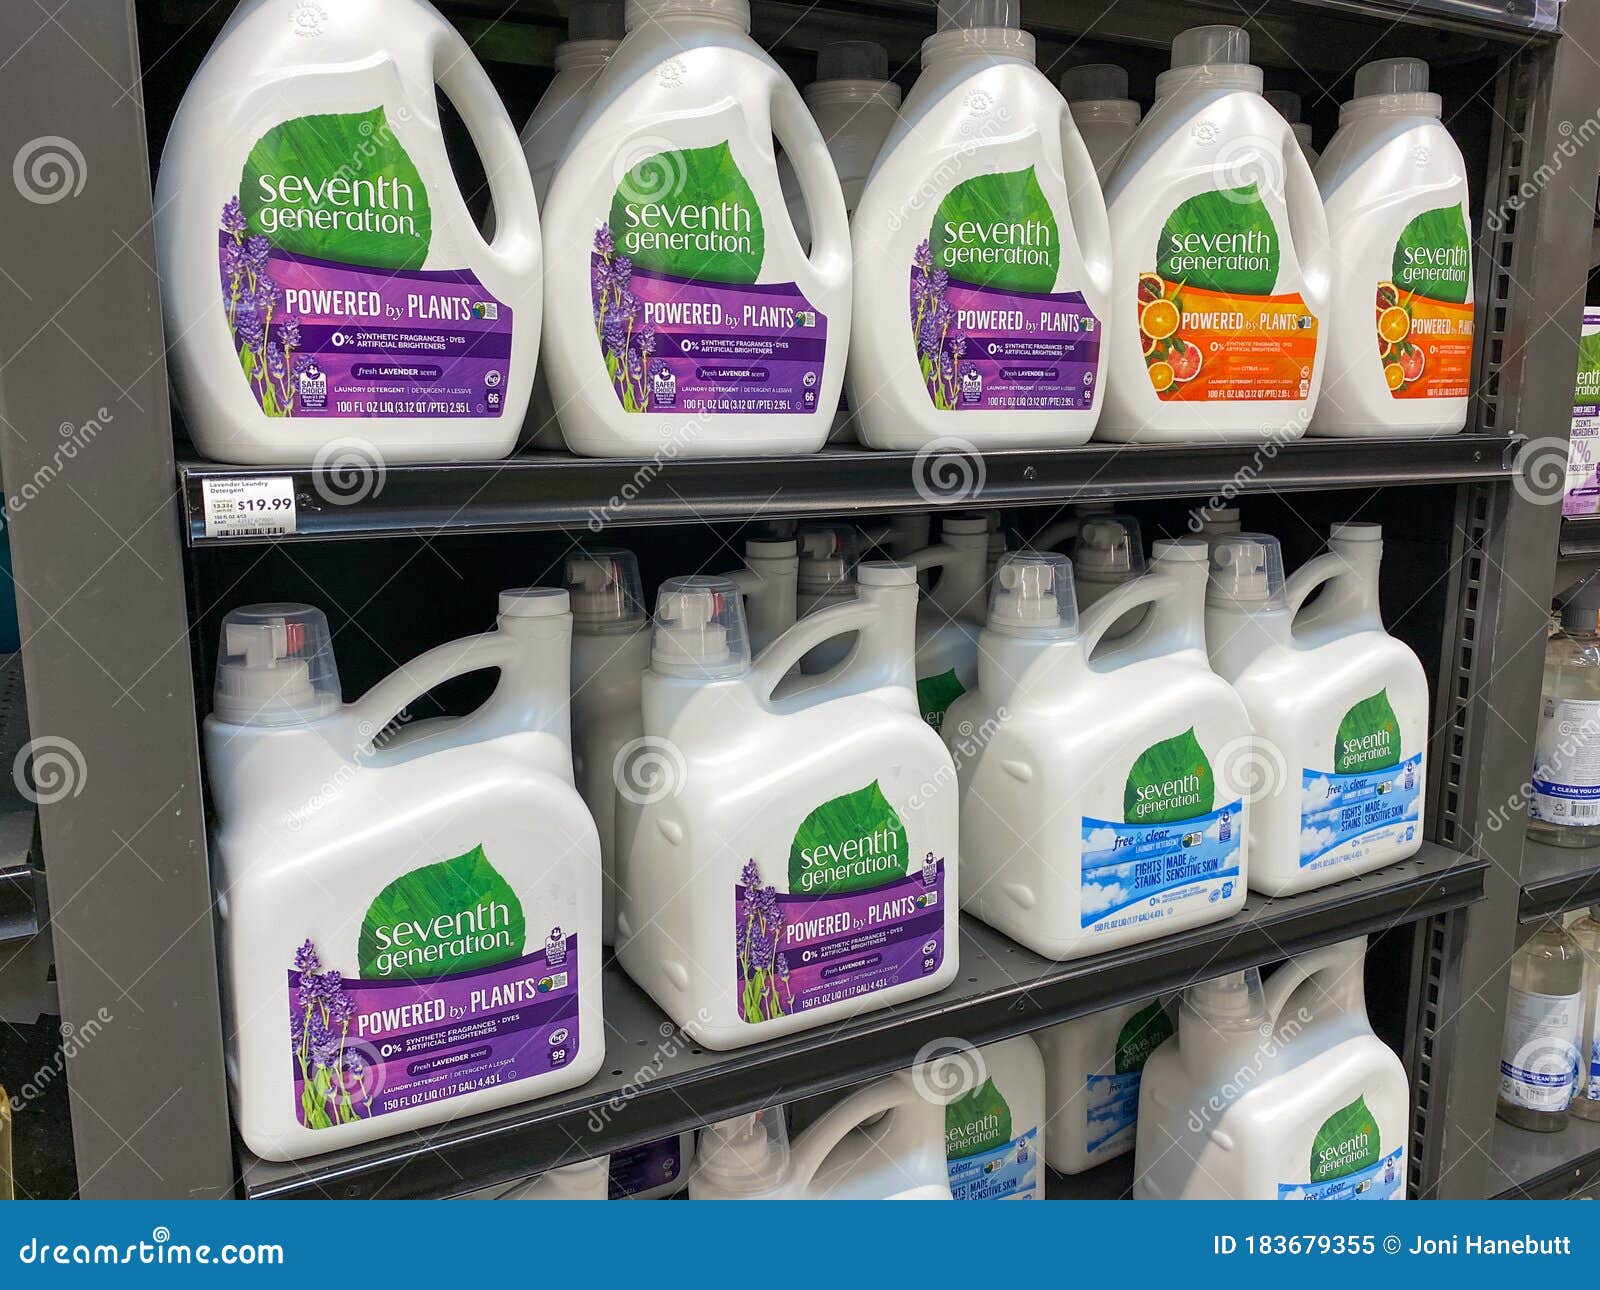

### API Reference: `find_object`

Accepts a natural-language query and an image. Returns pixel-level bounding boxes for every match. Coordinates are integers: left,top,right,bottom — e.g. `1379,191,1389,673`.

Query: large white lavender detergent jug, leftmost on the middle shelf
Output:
205,587,604,1160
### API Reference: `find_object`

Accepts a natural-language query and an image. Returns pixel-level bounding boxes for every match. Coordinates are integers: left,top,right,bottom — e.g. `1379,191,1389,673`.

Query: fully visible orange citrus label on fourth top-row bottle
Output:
1139,274,1317,403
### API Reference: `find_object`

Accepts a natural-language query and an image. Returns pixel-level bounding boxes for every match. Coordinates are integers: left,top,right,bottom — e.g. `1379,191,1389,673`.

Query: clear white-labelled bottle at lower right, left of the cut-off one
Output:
1494,919,1584,1133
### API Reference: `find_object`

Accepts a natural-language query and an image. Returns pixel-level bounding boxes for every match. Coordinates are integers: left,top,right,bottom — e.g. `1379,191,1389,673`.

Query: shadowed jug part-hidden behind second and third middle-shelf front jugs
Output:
910,515,989,730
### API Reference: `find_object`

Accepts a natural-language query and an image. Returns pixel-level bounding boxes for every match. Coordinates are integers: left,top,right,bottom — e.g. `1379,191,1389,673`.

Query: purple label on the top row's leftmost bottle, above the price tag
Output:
219,227,512,419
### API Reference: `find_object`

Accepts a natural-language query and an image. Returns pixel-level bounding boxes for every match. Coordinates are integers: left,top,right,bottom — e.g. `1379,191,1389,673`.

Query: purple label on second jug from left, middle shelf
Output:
733,856,944,1024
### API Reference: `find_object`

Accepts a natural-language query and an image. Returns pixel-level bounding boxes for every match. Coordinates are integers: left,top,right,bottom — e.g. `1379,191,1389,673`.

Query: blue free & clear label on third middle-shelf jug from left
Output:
1082,800,1243,931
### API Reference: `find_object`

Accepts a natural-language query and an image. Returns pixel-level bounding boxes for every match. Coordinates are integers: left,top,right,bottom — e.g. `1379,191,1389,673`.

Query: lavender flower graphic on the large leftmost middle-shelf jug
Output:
290,941,378,1128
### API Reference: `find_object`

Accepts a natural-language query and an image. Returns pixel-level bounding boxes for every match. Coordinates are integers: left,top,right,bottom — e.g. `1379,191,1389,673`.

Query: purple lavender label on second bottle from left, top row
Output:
590,251,827,415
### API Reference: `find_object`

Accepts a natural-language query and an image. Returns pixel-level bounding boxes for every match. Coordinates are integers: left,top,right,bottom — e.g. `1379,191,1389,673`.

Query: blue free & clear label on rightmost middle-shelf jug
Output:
1301,752,1422,869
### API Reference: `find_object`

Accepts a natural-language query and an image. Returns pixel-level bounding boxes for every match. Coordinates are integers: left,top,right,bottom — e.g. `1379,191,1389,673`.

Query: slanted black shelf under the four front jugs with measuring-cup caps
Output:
240,843,1488,1199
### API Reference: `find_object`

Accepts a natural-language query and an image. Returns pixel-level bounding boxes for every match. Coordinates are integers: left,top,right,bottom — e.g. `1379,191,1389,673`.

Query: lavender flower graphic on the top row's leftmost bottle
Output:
221,197,307,416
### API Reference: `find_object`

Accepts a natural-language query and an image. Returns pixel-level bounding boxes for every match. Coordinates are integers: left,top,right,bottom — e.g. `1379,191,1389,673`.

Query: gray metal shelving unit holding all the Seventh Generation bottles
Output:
0,0,1600,1197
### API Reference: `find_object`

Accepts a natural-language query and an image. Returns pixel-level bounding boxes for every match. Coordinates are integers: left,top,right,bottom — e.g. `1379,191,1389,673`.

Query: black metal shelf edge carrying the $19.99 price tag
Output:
178,434,1520,547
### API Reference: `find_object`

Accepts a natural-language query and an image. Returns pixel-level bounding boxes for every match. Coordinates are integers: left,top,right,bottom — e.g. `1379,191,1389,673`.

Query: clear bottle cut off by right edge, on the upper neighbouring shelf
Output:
1528,578,1600,847
